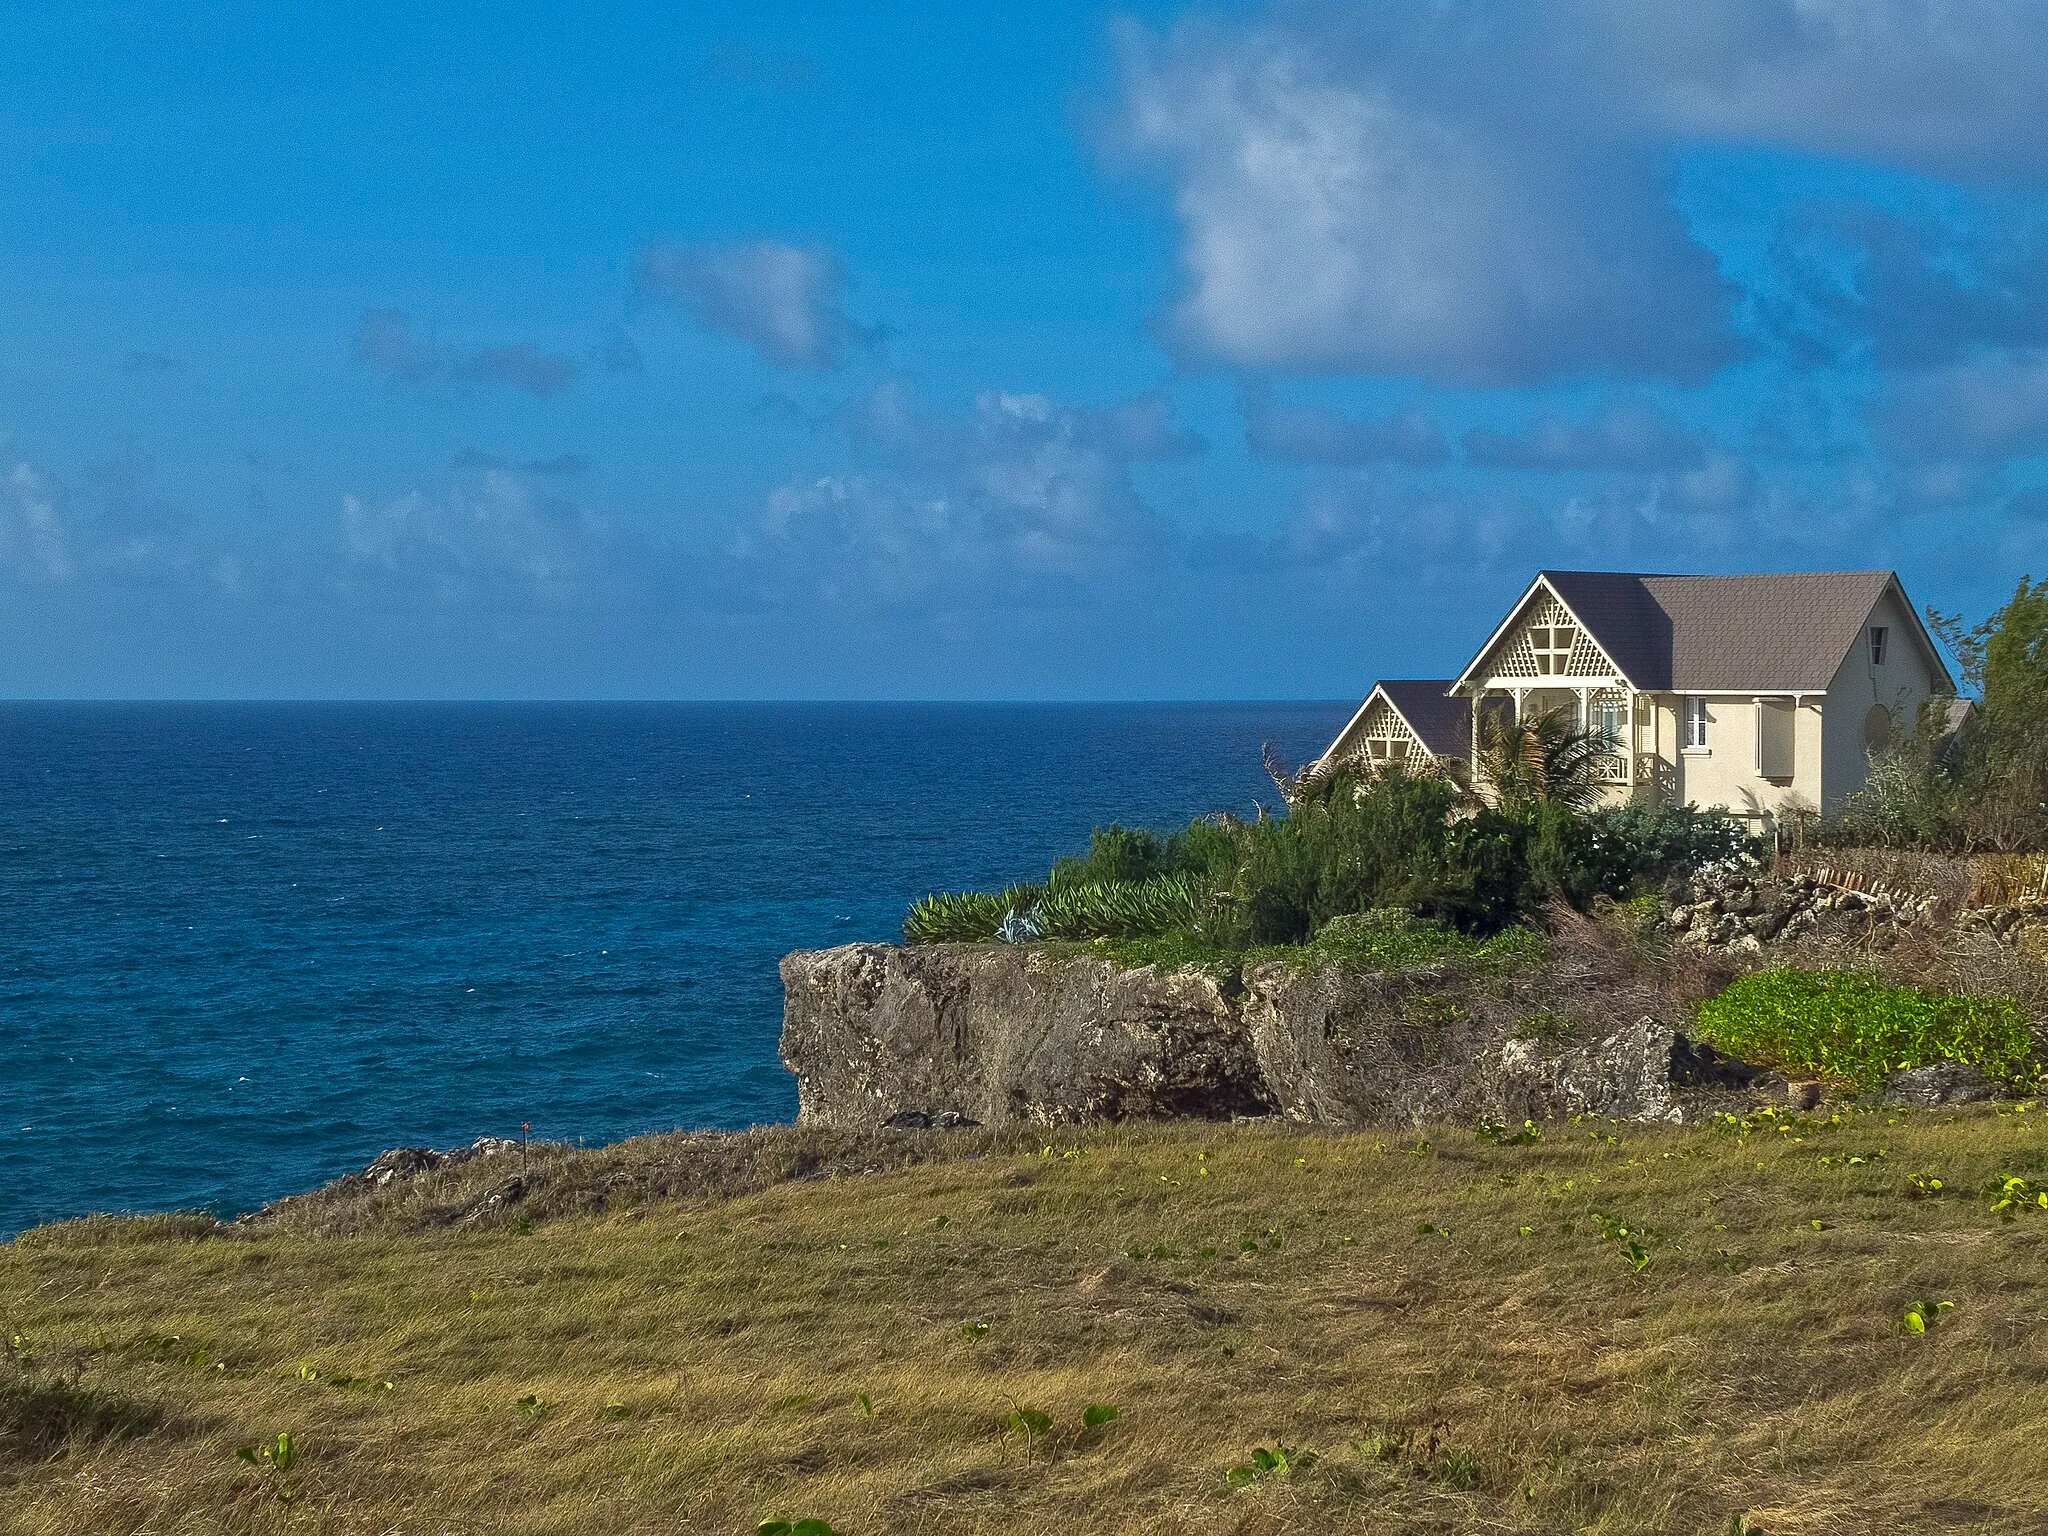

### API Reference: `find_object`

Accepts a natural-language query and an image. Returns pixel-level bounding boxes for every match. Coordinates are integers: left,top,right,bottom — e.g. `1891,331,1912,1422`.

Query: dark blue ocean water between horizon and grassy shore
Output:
0,705,1348,1235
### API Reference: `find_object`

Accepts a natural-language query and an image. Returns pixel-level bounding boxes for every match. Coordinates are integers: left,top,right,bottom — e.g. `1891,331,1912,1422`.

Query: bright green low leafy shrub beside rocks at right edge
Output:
1700,969,2040,1085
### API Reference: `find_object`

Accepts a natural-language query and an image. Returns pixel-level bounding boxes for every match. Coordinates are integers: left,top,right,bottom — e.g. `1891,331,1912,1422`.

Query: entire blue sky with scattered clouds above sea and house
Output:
0,0,2048,698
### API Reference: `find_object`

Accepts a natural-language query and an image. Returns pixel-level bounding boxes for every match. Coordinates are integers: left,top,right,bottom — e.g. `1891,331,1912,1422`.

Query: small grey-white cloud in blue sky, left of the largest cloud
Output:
637,240,881,369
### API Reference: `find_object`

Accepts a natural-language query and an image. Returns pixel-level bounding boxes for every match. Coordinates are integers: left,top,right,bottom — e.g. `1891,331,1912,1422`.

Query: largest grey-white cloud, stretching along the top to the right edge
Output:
1116,0,2048,385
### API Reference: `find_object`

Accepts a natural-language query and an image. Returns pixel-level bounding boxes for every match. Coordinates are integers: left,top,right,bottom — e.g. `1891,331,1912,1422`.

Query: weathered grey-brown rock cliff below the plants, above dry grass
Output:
782,944,1675,1128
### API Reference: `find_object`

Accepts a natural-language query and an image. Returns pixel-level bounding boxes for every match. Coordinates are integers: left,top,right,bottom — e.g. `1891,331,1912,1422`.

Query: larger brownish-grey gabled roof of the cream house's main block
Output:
1452,571,1954,692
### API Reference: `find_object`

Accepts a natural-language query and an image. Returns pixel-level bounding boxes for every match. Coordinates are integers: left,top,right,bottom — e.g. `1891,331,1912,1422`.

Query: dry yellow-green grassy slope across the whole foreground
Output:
0,1110,2048,1536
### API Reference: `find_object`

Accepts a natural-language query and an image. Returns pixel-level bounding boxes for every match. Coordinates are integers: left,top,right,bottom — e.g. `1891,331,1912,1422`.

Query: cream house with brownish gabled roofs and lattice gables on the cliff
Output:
1325,571,1956,823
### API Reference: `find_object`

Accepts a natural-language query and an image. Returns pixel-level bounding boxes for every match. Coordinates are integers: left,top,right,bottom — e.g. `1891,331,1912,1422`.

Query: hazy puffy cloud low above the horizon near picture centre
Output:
727,383,1198,608
